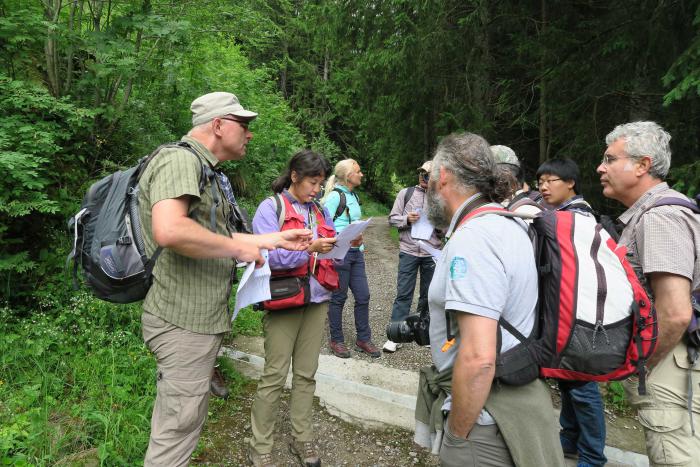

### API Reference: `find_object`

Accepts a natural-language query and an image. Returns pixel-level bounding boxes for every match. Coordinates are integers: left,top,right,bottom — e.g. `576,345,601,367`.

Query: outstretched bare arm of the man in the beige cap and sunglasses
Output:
152,196,310,265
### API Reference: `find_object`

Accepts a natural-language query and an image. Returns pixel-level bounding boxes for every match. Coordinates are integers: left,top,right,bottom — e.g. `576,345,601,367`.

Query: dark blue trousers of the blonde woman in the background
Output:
328,248,372,342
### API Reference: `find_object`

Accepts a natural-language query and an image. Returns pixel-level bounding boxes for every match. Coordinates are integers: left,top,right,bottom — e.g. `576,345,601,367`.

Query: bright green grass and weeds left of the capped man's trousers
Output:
0,294,155,465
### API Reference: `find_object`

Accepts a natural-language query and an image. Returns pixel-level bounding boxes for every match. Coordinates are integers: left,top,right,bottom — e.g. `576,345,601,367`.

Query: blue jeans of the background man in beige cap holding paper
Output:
391,252,435,321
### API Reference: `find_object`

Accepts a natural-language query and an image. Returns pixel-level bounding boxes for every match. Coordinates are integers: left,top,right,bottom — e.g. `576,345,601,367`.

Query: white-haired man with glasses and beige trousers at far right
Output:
597,122,700,466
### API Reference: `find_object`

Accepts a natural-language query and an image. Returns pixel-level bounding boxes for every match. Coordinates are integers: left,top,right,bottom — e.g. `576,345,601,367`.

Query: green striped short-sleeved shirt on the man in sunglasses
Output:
139,136,235,334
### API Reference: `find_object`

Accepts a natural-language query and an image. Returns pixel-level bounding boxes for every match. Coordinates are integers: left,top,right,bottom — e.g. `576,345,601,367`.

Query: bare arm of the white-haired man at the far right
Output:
649,272,693,367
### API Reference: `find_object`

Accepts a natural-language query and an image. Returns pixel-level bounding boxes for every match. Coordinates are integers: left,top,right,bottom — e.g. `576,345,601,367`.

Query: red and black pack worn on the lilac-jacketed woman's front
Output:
262,193,339,310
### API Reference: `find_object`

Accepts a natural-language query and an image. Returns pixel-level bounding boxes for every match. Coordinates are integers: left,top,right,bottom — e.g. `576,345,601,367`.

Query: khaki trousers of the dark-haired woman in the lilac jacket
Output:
250,302,328,454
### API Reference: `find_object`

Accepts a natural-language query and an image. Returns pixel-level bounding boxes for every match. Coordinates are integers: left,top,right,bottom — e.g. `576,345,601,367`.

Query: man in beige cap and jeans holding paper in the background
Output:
382,161,442,353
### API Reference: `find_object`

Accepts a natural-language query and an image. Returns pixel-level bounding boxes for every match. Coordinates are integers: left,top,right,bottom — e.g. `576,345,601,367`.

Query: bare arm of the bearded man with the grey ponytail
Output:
449,312,498,438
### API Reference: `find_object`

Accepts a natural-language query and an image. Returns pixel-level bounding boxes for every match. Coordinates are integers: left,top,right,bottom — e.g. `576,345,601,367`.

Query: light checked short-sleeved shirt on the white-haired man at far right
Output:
619,182,700,293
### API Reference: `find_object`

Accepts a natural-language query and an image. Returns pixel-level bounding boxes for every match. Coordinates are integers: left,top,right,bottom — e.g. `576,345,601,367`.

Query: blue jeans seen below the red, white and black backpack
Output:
559,381,607,466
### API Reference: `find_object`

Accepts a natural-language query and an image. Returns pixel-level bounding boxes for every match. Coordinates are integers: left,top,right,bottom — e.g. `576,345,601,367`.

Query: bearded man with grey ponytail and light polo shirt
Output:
416,133,564,467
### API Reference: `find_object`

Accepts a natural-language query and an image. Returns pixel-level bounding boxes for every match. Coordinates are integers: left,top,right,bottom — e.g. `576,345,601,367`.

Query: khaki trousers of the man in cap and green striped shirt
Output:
141,312,223,467
